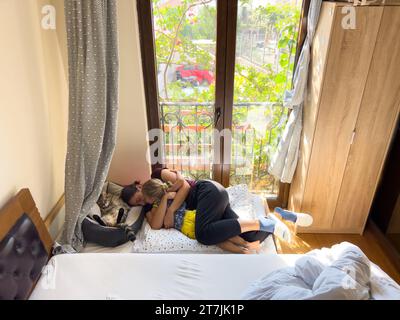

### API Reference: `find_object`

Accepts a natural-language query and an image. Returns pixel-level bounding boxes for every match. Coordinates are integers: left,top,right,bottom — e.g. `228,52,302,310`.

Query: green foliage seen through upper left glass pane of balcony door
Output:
153,0,216,101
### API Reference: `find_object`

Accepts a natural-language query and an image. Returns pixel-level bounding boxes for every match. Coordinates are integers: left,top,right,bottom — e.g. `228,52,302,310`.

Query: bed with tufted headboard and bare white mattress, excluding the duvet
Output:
0,189,400,300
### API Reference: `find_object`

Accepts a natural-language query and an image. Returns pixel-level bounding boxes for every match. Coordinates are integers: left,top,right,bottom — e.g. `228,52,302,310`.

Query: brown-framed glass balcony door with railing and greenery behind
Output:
137,0,300,204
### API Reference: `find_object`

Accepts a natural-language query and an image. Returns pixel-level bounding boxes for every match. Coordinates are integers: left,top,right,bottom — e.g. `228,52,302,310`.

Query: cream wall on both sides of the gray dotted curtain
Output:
0,0,150,217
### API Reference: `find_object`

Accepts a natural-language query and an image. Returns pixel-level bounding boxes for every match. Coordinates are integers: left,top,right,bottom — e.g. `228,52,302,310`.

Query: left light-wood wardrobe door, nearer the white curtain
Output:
298,6,383,232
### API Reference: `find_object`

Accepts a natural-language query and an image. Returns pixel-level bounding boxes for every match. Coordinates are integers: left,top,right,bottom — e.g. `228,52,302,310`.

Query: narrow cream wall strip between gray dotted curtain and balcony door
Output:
109,0,150,184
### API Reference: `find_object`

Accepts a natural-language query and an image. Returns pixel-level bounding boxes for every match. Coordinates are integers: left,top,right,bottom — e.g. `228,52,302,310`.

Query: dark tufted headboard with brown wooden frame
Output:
0,189,52,300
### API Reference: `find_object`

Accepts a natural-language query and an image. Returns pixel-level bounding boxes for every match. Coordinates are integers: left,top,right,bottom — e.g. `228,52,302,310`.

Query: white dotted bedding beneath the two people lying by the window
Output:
132,185,276,253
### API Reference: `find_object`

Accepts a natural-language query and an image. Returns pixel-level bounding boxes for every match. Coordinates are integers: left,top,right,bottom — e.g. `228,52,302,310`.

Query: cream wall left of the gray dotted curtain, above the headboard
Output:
0,0,67,217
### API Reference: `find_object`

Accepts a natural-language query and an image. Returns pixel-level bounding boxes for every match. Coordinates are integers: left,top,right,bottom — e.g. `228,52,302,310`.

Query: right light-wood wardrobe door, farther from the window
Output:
333,6,400,233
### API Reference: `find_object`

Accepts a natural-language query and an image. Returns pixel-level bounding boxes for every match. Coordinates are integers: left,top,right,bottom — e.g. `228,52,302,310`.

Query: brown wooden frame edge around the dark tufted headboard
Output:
0,189,53,257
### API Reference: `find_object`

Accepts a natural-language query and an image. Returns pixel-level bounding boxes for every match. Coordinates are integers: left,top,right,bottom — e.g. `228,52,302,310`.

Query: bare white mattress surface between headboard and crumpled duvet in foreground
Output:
30,253,297,300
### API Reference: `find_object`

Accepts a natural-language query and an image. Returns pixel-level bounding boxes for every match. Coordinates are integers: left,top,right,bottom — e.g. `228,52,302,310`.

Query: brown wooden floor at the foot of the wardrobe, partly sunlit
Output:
276,218,400,283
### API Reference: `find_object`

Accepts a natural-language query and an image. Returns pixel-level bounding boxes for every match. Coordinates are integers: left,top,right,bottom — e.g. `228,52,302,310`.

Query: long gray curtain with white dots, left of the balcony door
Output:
60,0,119,251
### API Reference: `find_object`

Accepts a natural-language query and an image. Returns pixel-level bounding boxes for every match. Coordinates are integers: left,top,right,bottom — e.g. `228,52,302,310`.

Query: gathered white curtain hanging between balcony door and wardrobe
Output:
268,0,322,183
